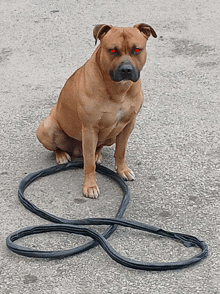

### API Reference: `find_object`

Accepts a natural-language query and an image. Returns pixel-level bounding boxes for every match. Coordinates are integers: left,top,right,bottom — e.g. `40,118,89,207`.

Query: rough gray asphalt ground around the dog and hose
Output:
0,0,220,294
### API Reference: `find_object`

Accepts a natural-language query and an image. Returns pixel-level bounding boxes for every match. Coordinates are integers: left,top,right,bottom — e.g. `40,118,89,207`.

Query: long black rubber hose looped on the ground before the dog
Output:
6,162,208,271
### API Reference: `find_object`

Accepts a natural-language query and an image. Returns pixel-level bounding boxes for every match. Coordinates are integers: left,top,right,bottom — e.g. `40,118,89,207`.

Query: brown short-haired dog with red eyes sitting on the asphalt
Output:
37,23,157,198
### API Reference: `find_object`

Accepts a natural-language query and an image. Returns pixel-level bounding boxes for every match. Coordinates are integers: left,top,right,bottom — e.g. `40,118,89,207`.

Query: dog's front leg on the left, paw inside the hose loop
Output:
82,127,100,198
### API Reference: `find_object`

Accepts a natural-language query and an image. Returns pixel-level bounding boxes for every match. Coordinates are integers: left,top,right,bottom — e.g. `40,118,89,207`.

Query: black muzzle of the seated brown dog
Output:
110,61,140,82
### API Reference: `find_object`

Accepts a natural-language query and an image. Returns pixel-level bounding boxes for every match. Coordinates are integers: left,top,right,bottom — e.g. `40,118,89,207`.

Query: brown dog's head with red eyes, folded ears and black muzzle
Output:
93,23,157,82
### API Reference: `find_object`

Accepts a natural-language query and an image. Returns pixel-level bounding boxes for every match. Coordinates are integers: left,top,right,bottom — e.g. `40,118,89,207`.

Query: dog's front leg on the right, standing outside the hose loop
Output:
114,118,135,181
